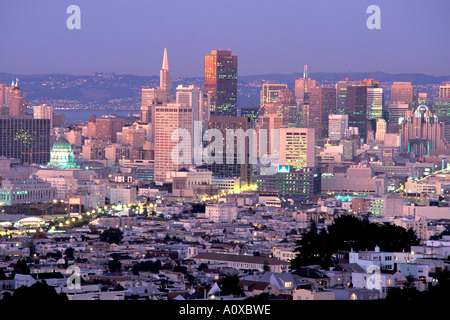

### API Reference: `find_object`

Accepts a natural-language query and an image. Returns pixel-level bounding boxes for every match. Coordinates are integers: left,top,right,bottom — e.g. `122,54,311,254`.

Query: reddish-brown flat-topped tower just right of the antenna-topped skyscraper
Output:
308,87,336,138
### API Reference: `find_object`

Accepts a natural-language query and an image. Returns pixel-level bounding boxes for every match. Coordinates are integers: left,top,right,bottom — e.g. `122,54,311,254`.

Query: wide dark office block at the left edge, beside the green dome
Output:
0,116,51,164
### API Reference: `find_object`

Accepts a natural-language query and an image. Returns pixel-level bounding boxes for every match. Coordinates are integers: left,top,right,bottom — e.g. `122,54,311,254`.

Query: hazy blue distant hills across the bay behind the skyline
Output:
0,71,450,108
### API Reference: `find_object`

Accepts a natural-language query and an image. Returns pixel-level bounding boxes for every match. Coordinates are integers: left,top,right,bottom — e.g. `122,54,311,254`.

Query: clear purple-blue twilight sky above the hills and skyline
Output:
0,0,450,77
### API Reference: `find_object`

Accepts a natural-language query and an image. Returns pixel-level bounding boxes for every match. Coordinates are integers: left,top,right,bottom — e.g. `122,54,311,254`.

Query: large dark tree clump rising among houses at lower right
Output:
291,215,419,269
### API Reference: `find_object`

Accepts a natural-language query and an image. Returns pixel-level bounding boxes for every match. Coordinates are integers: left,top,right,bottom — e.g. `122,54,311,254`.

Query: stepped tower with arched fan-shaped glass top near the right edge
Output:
401,105,450,156
